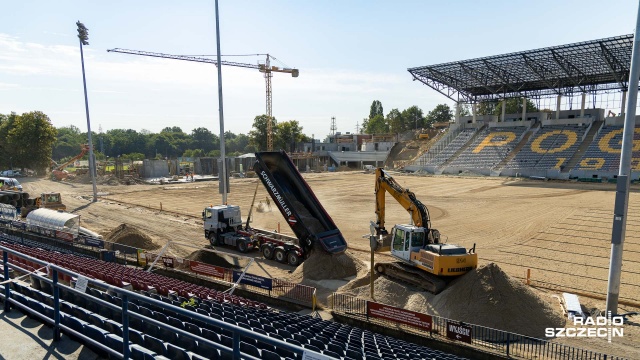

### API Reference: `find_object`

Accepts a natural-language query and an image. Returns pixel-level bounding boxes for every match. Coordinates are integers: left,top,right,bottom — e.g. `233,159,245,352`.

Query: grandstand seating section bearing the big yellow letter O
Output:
505,125,588,170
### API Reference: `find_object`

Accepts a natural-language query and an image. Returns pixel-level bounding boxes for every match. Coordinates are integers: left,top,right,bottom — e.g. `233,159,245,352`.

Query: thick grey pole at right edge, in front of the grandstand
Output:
607,0,640,315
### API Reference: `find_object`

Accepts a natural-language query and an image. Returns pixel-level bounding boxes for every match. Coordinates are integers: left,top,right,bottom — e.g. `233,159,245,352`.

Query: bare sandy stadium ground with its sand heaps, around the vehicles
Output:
7,162,640,358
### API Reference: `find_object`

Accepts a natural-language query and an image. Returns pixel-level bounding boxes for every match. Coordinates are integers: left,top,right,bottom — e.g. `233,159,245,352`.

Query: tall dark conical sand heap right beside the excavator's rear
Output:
431,263,565,338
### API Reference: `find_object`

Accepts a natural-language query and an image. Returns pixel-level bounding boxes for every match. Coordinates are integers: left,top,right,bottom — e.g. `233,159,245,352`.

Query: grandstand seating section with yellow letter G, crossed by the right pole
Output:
574,126,640,171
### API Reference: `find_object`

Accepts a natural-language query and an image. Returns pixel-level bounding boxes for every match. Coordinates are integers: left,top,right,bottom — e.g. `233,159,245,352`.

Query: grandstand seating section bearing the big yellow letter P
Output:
449,126,528,168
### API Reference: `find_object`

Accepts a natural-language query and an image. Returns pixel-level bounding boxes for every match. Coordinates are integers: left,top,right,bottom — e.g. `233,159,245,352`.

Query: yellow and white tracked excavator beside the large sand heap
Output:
371,168,478,294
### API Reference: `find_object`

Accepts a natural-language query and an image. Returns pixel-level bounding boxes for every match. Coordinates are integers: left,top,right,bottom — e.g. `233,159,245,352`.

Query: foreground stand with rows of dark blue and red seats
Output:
0,241,470,360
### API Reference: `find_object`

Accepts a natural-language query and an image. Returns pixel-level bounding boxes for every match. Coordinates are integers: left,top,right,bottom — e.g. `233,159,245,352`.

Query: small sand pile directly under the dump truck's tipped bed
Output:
290,250,365,282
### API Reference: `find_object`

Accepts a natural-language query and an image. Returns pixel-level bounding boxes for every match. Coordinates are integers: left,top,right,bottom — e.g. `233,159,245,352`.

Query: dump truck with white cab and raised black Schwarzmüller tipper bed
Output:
202,151,347,266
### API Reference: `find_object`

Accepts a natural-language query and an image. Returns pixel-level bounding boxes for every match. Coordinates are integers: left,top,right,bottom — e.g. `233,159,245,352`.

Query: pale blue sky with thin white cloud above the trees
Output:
0,0,638,139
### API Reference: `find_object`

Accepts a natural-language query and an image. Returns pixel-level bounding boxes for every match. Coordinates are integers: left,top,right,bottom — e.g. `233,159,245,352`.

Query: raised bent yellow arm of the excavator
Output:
375,168,431,235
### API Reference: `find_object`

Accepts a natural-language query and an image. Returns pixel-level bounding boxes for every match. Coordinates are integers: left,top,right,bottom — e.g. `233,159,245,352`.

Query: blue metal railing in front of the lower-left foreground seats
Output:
0,245,322,359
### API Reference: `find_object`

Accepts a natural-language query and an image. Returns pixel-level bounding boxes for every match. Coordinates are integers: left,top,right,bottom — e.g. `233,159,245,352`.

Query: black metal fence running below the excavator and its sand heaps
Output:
331,293,624,360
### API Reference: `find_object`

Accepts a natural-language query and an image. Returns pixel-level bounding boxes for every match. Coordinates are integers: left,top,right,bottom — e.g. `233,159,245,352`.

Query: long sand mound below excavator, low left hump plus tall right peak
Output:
343,263,565,338
